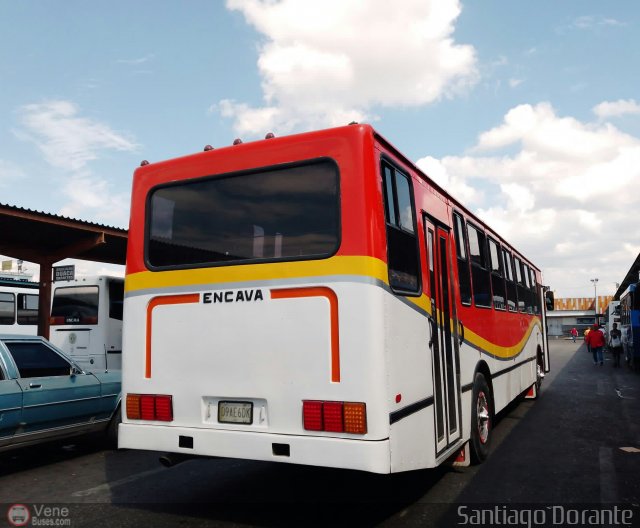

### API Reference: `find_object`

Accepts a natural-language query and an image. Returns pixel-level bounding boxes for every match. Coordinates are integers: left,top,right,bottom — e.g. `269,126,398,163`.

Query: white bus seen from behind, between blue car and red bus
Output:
49,276,124,371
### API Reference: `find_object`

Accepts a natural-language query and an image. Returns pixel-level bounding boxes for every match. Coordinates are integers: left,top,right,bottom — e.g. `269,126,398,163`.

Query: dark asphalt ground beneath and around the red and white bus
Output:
0,340,640,526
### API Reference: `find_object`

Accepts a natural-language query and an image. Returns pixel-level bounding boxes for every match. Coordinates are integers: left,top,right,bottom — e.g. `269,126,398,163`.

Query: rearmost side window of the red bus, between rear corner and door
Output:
382,162,420,295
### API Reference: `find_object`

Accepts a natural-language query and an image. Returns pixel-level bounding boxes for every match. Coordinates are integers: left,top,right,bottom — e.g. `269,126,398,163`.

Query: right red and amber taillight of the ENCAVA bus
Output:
302,400,367,434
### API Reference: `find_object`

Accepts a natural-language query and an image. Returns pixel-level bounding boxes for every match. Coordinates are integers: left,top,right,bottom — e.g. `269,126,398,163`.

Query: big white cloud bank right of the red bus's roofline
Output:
418,103,640,297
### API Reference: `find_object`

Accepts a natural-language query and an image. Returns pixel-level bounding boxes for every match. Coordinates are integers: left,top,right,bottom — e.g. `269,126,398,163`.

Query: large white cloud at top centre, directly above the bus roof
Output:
219,0,477,135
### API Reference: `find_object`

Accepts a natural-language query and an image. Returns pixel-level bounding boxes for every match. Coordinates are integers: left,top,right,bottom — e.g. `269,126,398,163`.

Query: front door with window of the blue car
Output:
5,340,101,433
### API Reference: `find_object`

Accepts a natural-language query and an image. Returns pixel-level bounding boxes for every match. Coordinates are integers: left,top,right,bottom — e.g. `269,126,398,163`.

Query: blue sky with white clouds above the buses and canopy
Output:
0,0,640,297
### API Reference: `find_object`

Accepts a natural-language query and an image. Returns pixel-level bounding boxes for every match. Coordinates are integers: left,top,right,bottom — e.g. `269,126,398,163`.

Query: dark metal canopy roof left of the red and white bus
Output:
0,204,127,265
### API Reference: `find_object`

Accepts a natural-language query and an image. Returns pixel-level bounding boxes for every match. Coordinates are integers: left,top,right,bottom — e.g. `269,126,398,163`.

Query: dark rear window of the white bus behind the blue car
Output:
51,286,98,325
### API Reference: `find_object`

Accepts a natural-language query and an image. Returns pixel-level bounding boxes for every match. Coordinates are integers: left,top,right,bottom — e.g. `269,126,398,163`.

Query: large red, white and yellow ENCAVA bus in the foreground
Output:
119,124,549,473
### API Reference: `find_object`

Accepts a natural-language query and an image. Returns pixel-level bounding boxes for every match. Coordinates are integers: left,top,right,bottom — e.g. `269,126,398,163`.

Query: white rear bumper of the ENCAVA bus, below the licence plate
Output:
118,423,391,473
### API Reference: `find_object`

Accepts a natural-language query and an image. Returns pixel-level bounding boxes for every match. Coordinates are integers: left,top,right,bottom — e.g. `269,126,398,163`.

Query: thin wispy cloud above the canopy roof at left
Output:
15,101,137,226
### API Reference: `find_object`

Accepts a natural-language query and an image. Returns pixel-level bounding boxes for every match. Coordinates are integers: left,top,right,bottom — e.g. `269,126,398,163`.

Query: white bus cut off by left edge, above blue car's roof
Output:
0,278,38,335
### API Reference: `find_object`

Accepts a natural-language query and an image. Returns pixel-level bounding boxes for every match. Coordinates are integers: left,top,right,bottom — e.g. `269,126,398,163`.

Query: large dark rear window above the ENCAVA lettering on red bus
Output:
147,160,340,267
